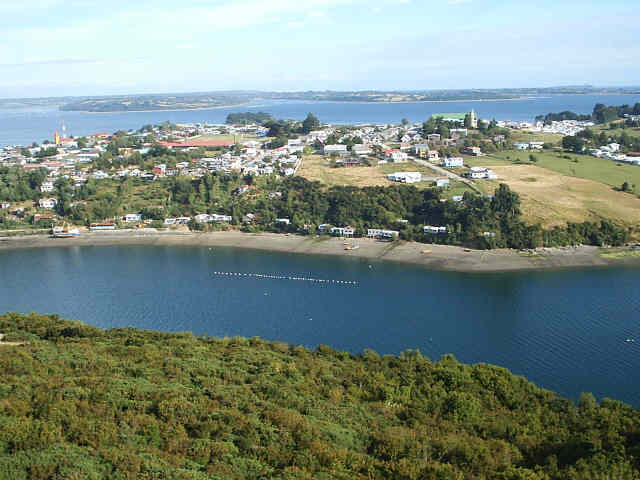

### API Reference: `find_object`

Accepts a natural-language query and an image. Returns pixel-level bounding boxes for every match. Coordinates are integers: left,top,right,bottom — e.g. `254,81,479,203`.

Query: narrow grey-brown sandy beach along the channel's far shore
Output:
0,229,640,272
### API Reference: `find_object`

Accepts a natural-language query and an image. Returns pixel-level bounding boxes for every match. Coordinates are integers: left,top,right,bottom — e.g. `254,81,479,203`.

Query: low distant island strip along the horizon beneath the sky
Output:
42,86,640,113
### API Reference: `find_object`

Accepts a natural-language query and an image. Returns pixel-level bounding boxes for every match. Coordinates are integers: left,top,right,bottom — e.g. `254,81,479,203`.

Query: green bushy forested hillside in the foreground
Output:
0,314,640,480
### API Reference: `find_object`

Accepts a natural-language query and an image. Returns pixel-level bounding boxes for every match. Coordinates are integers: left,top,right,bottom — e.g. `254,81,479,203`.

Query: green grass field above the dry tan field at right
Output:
488,151,640,193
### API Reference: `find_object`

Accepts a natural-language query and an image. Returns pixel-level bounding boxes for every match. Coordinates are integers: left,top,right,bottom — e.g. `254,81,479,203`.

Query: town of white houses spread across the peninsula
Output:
0,103,640,249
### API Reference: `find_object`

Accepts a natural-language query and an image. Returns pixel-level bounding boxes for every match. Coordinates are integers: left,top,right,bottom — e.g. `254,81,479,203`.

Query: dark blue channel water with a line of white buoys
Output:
0,247,640,407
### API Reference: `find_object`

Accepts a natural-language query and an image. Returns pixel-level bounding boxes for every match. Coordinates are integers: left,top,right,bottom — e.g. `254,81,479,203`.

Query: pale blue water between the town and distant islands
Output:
0,94,640,146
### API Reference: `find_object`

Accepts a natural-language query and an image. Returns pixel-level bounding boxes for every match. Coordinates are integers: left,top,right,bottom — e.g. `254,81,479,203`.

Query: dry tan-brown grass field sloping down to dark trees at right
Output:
477,162,640,227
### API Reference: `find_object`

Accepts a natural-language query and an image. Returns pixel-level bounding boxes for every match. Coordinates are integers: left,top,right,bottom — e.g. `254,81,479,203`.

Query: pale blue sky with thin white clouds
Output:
0,0,640,98
